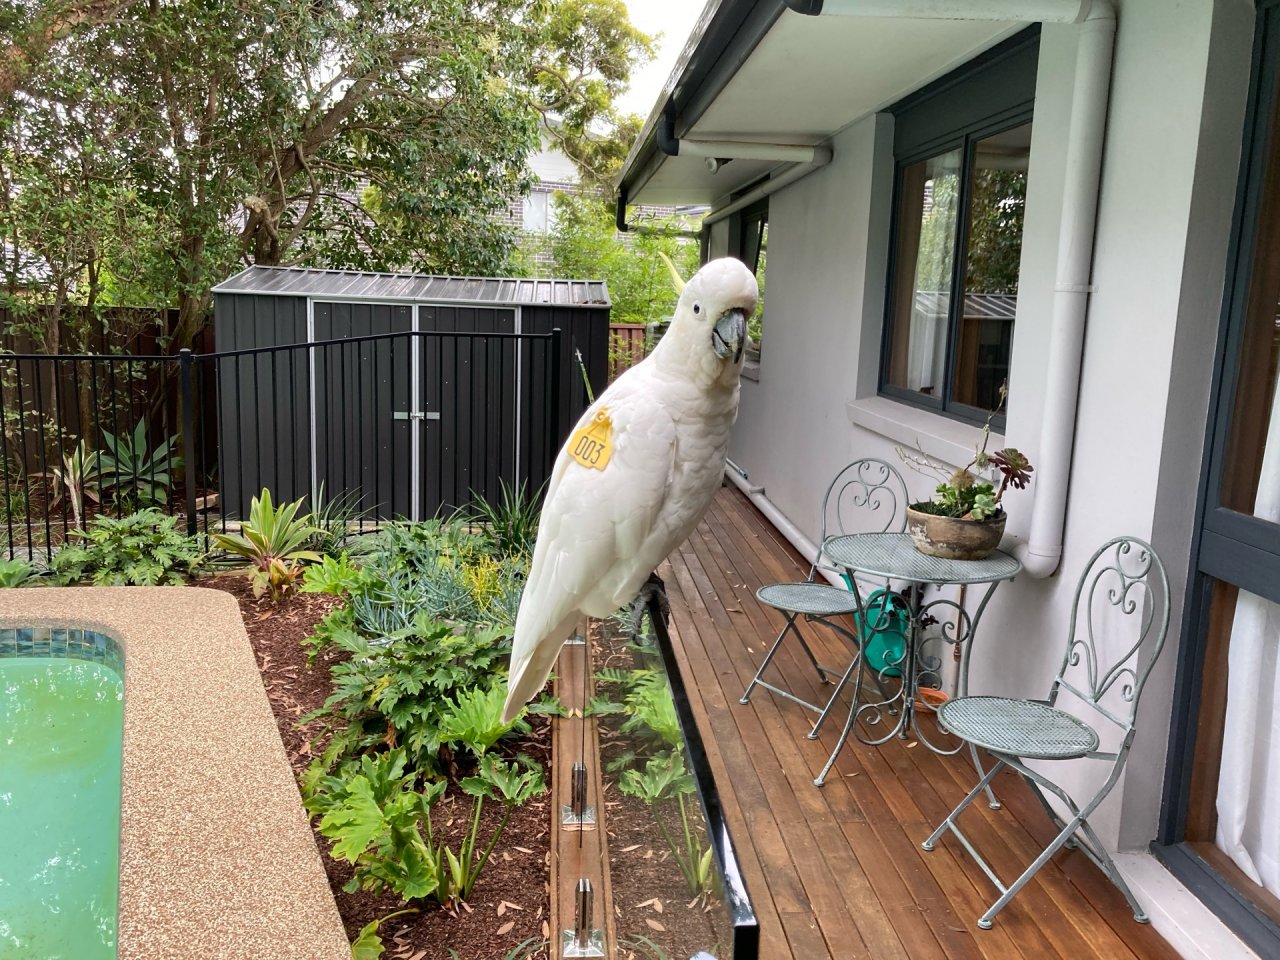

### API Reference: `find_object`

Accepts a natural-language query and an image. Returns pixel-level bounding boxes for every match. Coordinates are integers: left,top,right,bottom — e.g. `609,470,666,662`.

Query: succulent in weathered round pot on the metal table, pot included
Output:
897,387,1033,559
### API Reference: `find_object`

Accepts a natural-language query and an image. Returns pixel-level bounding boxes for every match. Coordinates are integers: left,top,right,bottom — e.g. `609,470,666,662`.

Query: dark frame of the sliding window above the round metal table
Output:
877,26,1041,430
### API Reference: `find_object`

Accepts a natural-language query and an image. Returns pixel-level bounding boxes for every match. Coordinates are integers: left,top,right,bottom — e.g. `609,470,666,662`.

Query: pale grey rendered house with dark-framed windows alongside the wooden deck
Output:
620,0,1280,960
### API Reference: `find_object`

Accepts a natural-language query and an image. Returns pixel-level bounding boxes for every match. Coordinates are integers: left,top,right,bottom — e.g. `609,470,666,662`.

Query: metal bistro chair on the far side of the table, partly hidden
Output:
740,457,908,740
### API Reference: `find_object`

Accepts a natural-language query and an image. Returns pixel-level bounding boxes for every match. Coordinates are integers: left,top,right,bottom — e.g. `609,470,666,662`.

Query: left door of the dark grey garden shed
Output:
311,301,412,518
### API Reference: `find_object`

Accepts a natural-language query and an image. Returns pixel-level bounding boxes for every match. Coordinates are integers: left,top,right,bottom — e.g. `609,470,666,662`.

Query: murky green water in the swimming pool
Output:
0,655,124,960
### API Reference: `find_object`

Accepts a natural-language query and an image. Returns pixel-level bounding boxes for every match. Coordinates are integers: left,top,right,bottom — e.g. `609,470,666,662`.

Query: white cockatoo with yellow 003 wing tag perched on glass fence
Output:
503,257,759,721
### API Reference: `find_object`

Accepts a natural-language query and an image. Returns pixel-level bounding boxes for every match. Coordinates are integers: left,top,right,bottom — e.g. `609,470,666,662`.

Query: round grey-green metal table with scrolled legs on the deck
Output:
814,534,1023,788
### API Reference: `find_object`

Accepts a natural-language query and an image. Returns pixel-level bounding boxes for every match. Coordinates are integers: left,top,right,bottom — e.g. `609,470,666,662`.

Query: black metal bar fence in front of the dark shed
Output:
0,329,565,561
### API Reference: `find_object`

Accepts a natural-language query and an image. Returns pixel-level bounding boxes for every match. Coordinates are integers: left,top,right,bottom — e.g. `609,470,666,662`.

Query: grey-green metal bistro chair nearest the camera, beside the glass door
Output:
923,536,1169,929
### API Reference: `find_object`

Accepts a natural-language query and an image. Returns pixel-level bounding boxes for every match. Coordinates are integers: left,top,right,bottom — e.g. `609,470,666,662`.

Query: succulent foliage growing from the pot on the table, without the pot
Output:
897,384,1033,520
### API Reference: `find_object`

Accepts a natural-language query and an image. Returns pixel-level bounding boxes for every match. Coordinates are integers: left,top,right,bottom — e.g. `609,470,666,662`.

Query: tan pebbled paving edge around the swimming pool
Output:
0,586,351,960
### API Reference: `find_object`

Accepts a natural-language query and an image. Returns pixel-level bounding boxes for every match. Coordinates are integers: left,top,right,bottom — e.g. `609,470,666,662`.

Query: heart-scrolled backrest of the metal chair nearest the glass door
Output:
1048,536,1169,737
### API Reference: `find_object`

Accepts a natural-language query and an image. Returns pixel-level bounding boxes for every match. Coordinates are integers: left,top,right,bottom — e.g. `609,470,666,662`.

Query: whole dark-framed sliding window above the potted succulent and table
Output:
881,31,1039,422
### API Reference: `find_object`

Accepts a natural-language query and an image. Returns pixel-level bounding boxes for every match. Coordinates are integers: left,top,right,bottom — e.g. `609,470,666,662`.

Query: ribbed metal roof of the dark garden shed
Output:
214,266,609,307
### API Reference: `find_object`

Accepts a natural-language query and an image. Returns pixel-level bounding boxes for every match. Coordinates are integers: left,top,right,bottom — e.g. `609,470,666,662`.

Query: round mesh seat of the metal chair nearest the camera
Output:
938,696,1098,760
